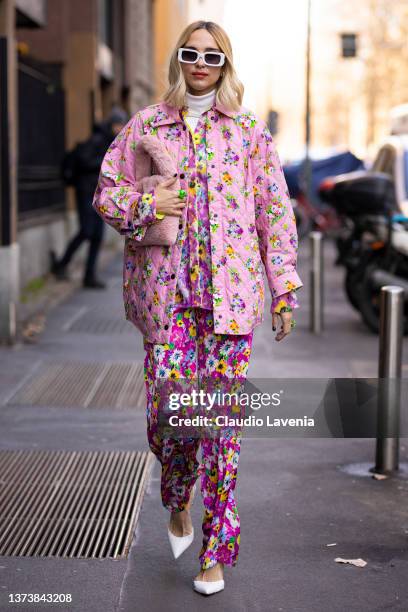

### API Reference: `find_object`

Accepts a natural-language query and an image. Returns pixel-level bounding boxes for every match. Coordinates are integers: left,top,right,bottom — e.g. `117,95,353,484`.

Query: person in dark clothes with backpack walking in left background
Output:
50,106,129,289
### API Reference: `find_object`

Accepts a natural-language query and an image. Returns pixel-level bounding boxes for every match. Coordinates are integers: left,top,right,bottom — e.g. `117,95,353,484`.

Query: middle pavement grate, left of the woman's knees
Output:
7,362,146,410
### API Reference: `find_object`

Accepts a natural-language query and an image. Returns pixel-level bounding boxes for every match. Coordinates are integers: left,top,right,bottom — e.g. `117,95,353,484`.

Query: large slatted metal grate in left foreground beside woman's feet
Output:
0,451,154,559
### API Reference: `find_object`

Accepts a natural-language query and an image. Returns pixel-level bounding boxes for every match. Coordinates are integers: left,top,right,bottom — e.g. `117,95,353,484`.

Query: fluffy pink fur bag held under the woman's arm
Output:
134,134,184,246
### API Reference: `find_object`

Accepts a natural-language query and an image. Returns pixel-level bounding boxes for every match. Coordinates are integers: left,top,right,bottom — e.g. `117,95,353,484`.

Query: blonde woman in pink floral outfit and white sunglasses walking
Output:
93,21,302,594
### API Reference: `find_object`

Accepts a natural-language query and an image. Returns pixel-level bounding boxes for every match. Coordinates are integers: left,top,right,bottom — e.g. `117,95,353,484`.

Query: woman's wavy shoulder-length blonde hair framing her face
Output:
161,21,244,111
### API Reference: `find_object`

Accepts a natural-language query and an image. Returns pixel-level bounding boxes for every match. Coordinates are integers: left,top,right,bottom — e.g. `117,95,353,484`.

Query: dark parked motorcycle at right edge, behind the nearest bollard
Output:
319,171,408,333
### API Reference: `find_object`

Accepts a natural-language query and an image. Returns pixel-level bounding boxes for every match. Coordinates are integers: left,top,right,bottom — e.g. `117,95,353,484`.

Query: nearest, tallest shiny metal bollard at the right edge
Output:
371,285,404,474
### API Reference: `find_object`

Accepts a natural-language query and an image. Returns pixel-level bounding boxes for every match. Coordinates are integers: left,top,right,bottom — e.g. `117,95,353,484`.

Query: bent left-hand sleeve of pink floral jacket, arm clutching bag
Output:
92,113,157,240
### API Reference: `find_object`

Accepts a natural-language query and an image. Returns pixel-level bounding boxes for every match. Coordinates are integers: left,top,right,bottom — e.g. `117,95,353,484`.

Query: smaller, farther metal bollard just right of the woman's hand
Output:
309,232,324,334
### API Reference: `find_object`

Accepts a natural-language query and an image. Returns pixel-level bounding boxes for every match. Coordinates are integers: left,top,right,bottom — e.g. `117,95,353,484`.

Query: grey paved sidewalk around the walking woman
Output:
0,237,408,612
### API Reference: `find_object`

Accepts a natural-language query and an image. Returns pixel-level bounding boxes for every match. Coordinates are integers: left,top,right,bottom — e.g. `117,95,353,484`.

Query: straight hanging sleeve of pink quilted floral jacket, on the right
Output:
249,118,303,304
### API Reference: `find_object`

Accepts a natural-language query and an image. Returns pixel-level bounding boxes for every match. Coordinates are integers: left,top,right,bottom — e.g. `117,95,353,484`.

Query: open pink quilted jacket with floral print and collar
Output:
93,102,303,343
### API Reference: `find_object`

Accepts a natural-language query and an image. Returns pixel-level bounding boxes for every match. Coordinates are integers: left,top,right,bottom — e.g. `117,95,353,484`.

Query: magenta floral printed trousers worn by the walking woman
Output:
143,306,253,569
